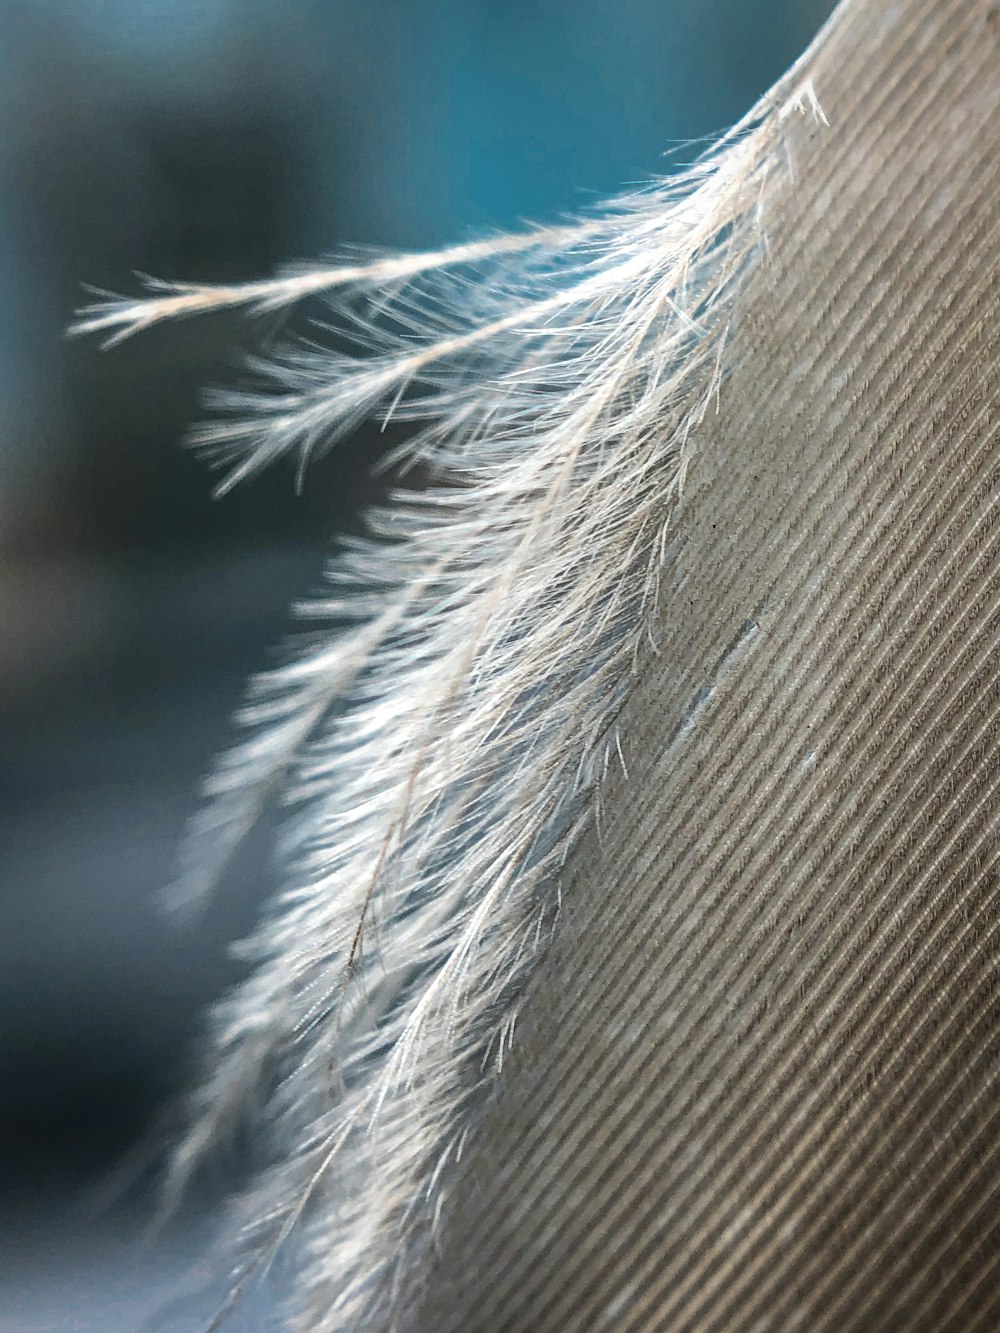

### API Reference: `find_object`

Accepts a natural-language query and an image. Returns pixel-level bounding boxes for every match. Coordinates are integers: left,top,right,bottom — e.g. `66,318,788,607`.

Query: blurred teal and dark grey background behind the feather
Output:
0,0,832,1333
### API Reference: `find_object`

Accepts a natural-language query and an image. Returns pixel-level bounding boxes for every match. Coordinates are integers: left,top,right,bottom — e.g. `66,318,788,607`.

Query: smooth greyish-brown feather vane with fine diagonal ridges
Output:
409,0,1000,1333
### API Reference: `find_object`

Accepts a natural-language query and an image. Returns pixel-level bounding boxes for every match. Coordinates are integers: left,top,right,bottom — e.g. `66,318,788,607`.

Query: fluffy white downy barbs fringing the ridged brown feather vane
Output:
68,7,837,1333
